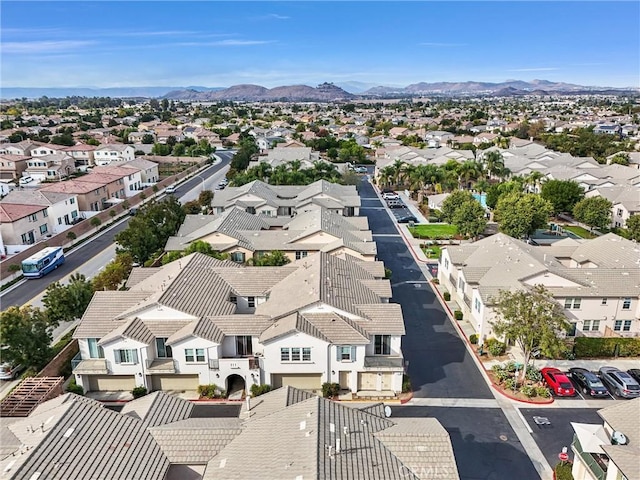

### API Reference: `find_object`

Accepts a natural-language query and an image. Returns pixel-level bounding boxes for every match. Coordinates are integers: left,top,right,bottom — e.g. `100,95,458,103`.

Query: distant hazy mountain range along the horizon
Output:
0,80,640,102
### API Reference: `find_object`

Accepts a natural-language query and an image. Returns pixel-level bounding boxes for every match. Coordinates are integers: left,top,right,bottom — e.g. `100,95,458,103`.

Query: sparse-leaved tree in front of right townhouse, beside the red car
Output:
493,285,570,377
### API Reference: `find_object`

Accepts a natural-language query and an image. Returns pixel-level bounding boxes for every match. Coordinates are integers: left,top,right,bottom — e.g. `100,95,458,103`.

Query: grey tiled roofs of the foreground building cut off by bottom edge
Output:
0,387,459,480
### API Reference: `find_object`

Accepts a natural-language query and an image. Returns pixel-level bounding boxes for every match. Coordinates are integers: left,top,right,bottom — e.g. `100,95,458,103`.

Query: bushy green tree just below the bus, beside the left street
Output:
42,273,93,327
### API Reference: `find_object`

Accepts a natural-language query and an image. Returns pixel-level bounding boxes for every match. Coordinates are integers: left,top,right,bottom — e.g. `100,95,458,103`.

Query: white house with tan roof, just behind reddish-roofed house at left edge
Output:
0,189,81,234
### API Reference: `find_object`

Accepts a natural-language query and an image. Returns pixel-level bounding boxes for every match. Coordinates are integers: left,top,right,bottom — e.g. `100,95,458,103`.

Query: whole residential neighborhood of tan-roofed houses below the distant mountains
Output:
0,91,640,480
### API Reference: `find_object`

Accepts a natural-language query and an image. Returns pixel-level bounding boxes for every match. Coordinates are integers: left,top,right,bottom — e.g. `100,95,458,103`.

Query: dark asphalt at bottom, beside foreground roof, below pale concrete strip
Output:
391,406,540,480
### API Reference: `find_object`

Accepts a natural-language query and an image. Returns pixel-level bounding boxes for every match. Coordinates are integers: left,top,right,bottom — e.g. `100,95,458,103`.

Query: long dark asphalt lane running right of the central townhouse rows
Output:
359,181,493,398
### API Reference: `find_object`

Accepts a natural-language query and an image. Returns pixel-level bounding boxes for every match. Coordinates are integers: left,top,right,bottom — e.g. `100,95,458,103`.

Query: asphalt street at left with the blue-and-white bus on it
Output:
0,156,233,310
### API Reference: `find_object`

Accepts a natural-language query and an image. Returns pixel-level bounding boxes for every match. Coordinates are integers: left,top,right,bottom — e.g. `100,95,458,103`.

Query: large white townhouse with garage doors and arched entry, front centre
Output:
73,252,404,397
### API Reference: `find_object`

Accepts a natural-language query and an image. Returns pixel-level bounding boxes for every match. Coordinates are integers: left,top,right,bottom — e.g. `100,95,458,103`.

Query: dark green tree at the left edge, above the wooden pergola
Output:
0,305,52,370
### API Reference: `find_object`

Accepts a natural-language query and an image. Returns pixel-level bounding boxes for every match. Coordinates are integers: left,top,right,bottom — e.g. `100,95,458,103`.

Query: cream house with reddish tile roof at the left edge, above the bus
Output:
0,202,53,251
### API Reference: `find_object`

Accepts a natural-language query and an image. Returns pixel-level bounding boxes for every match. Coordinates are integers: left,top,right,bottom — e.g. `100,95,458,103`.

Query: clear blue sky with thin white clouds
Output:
0,1,640,87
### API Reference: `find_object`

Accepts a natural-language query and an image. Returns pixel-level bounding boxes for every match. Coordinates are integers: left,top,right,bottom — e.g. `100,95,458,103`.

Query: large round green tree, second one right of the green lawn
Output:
495,192,553,238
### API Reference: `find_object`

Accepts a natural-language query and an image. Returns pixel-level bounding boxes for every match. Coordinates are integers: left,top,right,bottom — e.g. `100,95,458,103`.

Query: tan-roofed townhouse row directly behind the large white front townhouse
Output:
165,207,377,263
